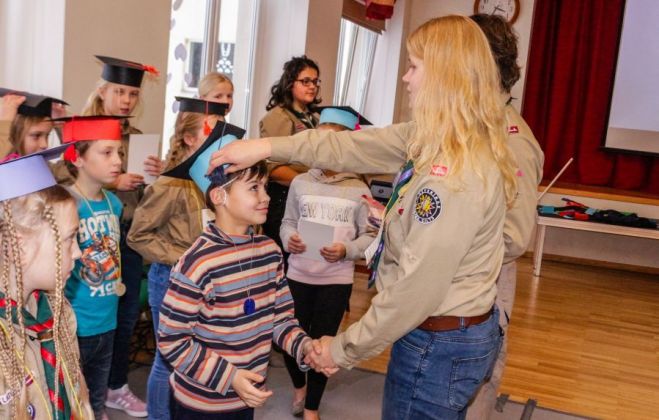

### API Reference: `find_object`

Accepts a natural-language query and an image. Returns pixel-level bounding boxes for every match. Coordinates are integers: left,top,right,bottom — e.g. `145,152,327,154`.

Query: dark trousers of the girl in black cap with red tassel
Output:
108,231,143,389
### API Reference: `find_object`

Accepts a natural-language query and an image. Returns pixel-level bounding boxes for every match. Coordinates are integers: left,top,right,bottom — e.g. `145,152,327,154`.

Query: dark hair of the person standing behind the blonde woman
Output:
471,14,520,93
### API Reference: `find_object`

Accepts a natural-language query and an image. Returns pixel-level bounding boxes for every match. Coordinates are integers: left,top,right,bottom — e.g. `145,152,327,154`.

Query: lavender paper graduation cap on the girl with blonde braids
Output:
0,145,67,201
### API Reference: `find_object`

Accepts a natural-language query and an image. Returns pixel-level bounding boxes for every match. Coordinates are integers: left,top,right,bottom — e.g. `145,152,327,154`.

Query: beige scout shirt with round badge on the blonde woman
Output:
272,123,506,368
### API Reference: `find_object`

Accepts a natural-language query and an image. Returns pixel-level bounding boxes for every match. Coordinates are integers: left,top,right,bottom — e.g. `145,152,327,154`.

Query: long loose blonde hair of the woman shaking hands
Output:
407,16,517,204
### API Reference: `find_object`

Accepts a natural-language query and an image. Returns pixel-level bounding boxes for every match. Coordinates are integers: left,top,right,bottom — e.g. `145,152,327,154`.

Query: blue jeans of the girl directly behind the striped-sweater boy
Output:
146,263,172,420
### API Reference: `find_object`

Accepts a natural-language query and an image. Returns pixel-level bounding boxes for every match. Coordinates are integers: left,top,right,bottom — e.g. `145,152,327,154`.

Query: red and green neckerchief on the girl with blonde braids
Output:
0,290,71,419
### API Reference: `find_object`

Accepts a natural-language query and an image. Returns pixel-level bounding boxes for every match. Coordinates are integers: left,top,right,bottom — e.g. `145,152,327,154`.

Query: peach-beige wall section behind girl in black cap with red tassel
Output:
63,0,171,133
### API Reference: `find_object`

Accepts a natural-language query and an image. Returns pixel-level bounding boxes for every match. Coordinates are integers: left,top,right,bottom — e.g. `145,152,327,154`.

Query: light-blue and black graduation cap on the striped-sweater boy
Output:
162,121,245,194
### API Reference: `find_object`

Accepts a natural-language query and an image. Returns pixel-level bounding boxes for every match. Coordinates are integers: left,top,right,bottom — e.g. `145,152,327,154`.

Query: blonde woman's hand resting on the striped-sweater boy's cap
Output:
207,138,272,174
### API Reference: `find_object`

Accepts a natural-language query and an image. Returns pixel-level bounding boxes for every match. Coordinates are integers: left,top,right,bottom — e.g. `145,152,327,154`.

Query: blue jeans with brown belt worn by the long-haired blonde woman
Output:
382,307,502,420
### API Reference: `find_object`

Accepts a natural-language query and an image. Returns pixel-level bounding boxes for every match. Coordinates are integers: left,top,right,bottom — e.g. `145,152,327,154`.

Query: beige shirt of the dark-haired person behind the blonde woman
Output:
503,105,545,263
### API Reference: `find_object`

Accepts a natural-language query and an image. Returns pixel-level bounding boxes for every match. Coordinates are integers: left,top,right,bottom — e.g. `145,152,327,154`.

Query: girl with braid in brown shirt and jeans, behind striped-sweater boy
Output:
128,98,228,419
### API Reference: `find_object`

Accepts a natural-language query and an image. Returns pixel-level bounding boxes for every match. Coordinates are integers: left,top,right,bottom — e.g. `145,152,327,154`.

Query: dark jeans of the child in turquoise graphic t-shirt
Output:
78,330,114,419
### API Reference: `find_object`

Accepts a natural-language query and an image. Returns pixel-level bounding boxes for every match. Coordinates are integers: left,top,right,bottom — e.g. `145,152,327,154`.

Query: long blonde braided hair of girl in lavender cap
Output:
0,185,89,419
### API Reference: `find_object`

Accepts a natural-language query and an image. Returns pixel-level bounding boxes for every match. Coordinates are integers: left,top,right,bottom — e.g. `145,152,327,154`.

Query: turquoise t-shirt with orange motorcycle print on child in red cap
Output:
65,190,122,337
